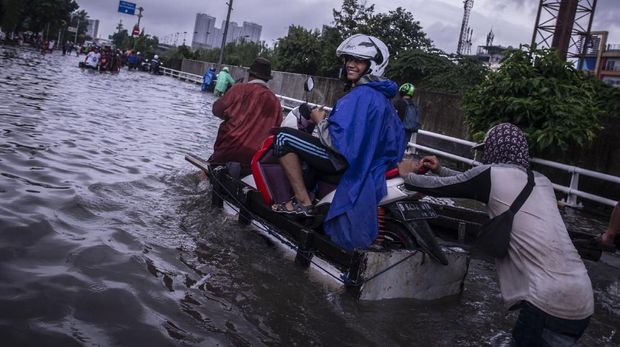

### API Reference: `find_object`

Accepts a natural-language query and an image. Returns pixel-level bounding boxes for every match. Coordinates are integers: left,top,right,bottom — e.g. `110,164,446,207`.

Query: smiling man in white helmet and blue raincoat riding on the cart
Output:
272,34,405,250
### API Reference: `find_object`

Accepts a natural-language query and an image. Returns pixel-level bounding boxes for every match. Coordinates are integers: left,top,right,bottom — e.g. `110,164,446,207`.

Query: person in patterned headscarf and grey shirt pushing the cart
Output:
399,123,594,346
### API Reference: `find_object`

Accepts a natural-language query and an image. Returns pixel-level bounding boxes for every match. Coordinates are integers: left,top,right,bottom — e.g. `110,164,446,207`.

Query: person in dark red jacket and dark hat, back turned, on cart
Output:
209,57,282,166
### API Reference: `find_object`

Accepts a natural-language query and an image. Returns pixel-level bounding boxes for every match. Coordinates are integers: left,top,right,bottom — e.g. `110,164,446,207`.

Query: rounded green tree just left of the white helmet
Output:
274,25,321,75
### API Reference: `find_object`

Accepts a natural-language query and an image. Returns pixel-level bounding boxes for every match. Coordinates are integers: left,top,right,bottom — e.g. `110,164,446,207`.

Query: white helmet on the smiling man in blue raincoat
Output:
336,34,390,77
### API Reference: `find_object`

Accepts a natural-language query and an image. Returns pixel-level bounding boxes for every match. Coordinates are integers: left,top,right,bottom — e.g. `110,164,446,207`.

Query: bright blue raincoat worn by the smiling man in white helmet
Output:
324,76,405,250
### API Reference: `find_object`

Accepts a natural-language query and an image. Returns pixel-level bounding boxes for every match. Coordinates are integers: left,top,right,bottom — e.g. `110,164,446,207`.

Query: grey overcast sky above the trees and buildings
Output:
76,0,620,53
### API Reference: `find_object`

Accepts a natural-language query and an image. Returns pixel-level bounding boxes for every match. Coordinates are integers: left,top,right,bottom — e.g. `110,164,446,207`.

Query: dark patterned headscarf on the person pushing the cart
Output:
481,123,530,169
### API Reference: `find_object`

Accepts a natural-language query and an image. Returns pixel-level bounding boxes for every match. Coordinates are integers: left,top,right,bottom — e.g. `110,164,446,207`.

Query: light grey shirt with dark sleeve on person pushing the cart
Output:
405,165,594,320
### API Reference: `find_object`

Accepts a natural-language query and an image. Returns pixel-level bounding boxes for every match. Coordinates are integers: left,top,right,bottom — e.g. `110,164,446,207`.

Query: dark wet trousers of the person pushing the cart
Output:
512,302,590,347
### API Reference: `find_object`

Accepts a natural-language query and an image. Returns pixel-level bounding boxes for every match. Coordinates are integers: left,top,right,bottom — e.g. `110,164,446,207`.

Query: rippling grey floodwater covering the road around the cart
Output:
0,47,620,346
